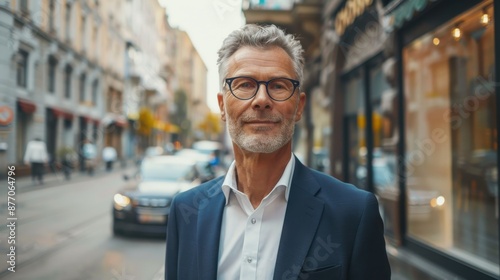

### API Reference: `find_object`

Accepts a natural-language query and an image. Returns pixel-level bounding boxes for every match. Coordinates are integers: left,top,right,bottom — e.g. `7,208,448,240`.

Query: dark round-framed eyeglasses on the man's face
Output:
226,77,300,101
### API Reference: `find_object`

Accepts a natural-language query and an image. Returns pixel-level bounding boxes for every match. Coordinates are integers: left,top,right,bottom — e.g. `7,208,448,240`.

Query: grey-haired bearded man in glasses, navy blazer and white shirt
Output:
165,25,390,280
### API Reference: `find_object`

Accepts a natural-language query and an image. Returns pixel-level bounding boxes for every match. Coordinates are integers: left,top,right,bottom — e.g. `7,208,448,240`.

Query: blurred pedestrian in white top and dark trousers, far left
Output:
24,137,49,184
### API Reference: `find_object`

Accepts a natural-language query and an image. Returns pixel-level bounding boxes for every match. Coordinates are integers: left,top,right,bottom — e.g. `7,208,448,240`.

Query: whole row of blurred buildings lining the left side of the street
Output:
0,0,188,173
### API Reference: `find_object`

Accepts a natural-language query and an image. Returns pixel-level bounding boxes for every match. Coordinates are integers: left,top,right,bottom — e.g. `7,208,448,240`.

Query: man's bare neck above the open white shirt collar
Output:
235,147,292,209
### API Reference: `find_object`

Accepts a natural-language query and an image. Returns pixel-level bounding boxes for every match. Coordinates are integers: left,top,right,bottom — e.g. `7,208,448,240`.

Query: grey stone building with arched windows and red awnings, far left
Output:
0,1,111,172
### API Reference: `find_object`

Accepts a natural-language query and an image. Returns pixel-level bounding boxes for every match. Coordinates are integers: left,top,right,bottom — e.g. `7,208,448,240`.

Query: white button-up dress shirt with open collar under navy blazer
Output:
217,155,295,280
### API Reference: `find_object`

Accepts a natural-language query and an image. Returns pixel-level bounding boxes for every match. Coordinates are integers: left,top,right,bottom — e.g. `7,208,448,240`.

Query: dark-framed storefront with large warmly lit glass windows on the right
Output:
332,0,500,279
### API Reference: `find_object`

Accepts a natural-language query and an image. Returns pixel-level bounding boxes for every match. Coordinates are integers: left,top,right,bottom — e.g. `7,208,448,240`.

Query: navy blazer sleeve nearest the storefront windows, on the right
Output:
348,193,391,280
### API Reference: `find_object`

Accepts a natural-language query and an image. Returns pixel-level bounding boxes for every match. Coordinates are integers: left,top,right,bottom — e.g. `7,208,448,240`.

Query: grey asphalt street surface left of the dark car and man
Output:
0,169,165,280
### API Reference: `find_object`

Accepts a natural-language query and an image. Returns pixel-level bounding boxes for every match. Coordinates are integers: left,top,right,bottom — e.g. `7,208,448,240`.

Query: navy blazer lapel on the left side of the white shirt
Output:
193,178,226,280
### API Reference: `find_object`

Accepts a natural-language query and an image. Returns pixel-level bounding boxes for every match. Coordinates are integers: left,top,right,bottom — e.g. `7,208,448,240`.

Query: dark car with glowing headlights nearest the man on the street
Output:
113,156,203,234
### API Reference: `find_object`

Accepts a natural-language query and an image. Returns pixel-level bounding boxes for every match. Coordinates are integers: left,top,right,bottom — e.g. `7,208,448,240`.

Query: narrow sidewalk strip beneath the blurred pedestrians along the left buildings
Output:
14,161,135,193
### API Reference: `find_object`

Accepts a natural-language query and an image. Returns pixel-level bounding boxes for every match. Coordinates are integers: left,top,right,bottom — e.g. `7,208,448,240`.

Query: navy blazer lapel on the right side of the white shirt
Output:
274,159,323,280
